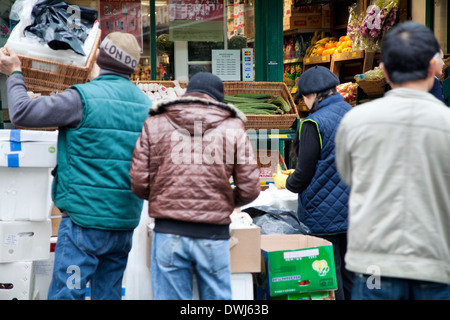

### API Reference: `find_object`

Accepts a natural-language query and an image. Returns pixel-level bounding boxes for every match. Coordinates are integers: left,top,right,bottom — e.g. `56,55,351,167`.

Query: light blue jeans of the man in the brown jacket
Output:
151,232,231,300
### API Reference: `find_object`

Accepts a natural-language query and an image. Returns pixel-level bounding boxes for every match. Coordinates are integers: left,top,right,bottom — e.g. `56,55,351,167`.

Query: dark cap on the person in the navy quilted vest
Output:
295,66,340,99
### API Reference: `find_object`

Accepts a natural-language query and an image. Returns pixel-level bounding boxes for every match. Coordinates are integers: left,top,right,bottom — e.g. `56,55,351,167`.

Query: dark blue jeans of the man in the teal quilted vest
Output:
48,217,133,300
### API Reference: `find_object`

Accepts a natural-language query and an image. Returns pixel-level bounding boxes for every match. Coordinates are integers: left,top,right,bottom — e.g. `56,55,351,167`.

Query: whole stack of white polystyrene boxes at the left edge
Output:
0,129,58,300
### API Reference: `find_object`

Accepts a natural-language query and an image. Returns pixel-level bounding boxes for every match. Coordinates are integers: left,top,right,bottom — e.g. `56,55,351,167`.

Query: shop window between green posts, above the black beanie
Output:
151,0,255,81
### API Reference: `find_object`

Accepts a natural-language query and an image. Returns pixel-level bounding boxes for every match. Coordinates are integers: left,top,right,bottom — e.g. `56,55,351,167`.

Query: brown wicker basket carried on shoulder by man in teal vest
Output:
19,30,101,92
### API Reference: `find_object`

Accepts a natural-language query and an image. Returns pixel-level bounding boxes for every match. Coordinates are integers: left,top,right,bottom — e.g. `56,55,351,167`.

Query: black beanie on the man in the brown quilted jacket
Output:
186,72,225,102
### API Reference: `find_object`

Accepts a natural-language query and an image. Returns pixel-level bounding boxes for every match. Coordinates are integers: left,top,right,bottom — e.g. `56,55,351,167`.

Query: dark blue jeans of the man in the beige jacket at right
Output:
352,274,450,300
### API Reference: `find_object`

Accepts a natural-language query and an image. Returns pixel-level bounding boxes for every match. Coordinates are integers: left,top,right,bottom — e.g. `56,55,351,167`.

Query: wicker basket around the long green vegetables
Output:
223,81,298,130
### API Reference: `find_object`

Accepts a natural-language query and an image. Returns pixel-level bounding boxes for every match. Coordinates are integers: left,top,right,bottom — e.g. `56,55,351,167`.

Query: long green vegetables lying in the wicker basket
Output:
224,93,291,115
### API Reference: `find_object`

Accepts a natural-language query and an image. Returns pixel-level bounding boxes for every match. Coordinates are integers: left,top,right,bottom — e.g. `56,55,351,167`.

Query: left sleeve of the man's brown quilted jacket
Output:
129,121,150,200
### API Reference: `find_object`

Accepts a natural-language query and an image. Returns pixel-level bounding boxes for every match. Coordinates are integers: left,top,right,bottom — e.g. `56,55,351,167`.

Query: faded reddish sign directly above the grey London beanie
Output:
99,0,143,53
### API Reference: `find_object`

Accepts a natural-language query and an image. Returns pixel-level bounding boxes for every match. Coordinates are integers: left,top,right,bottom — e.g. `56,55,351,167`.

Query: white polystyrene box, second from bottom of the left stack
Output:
0,219,52,263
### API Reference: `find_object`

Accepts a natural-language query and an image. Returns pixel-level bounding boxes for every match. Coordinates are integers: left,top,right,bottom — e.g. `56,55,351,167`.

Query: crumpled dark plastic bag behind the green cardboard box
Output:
242,206,311,235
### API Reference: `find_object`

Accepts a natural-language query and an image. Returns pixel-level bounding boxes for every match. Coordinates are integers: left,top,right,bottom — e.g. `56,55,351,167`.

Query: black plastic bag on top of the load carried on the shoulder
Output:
24,0,98,56
